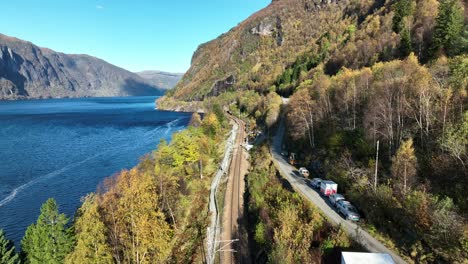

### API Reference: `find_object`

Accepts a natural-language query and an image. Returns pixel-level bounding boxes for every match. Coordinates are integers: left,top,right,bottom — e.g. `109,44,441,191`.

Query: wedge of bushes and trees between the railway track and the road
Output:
246,145,361,263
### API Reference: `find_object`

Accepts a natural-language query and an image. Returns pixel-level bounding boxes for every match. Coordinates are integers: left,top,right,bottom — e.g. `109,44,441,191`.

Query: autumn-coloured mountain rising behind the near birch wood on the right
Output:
161,0,468,103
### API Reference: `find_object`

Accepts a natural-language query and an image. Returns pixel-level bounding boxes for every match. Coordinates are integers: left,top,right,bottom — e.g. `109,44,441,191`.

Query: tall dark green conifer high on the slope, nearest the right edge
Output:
430,0,464,57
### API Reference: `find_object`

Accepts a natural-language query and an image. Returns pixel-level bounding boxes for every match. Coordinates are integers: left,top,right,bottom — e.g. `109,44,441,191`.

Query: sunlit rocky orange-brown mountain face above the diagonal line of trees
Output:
168,0,352,101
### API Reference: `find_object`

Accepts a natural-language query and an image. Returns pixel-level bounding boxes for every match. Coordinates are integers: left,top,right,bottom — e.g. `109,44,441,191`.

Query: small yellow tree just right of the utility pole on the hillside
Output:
392,139,417,196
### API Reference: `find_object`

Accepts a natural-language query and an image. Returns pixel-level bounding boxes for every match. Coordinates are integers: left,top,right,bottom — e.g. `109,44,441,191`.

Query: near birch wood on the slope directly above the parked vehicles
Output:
286,54,468,262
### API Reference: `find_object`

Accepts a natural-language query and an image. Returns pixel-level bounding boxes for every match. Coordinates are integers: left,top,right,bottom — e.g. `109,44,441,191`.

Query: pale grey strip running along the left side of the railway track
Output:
206,123,239,264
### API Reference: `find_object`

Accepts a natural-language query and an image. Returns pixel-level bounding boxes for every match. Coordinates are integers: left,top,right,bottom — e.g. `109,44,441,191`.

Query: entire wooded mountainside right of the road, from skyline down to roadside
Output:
158,0,468,263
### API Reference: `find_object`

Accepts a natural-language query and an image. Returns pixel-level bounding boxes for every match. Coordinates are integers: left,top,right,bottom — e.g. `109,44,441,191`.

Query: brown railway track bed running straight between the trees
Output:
219,117,248,264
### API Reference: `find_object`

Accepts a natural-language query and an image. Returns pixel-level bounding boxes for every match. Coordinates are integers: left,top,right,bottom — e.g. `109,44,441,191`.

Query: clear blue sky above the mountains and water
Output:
0,0,271,72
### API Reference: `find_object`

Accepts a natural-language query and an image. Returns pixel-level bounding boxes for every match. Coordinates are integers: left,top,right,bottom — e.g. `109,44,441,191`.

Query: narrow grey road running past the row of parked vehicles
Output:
271,119,406,264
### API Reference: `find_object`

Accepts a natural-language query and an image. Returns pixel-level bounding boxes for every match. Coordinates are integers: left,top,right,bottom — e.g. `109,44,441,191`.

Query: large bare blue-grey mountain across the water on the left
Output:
0,34,165,99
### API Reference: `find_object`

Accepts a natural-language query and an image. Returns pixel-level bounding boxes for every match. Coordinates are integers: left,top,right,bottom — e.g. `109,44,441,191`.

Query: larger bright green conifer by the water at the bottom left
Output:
21,198,73,264
